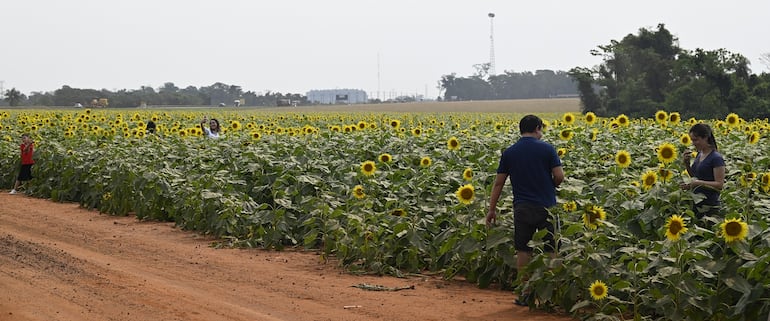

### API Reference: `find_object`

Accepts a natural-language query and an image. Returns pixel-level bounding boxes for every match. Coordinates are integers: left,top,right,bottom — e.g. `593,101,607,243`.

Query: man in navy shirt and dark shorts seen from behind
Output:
487,115,564,305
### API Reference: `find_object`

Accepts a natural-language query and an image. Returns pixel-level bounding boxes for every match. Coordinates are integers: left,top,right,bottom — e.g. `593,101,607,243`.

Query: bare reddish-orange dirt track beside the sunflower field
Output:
0,191,572,321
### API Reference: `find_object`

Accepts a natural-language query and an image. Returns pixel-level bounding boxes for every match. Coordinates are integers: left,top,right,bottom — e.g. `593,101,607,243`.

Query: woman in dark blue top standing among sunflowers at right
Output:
681,124,725,218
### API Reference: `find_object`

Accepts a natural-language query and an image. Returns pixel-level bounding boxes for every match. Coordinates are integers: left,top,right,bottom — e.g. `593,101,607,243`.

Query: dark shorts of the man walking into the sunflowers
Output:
513,204,556,252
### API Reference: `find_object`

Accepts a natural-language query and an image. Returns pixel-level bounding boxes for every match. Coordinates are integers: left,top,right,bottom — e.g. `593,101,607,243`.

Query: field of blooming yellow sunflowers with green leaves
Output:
0,109,770,320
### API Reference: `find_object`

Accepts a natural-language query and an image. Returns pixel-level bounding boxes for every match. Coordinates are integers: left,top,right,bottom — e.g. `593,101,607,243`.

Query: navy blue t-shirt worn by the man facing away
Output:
497,137,561,207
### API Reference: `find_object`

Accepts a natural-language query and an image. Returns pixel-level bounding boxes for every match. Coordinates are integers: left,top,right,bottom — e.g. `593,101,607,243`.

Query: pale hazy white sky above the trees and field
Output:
0,0,770,98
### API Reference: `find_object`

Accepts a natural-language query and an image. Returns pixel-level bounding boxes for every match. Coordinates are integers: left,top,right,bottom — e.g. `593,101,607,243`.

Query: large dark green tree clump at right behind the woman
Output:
569,24,770,118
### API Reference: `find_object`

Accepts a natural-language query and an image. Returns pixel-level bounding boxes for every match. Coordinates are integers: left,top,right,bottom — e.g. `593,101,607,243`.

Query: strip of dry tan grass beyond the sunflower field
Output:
255,98,580,113
